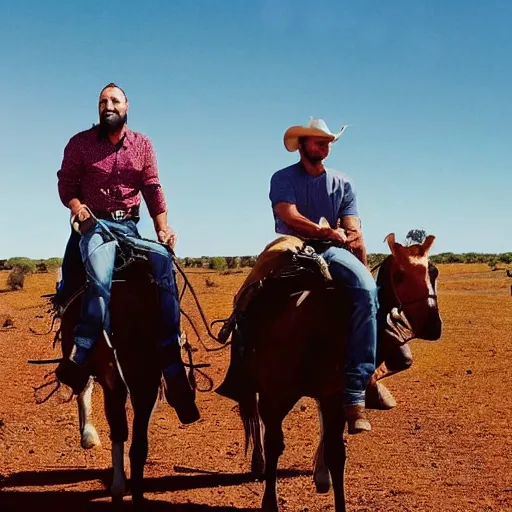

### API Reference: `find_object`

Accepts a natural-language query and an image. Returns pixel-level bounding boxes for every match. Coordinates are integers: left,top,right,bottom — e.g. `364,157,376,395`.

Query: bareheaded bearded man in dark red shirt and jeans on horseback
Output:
56,83,199,424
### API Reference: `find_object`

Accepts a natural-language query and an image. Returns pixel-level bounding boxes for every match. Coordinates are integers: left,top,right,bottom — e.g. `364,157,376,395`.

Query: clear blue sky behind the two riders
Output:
0,0,512,258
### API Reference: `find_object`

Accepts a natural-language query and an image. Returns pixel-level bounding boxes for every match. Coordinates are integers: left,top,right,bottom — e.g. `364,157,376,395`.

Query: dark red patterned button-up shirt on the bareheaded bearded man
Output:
57,126,167,218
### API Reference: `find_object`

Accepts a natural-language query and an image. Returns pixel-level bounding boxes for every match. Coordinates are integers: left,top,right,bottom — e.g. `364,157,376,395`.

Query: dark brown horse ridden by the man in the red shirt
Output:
61,261,166,508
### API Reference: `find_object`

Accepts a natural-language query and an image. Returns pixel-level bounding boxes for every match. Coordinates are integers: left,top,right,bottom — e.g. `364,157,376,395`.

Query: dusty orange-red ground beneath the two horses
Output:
0,265,512,512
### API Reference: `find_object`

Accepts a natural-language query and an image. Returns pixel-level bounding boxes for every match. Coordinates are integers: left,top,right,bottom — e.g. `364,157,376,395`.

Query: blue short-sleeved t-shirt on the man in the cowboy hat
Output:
269,162,359,235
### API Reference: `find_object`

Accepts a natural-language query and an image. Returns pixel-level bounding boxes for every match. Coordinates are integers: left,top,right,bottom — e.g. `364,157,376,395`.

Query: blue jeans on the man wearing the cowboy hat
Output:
322,247,378,405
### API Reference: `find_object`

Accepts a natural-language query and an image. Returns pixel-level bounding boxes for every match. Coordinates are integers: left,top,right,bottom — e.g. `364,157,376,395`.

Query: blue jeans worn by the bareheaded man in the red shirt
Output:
72,220,181,374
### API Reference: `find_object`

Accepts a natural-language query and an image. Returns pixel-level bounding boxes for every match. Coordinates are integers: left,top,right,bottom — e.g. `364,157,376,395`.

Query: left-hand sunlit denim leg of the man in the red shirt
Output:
72,225,116,364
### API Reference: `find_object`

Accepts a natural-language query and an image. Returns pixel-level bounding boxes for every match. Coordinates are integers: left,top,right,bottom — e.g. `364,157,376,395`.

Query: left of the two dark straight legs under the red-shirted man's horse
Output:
103,377,128,503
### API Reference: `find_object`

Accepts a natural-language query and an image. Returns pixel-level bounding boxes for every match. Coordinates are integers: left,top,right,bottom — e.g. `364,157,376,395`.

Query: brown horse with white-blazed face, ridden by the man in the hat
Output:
233,235,442,512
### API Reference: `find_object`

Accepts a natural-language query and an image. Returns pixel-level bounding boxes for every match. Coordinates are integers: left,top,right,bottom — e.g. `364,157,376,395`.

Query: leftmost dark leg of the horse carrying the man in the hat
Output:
259,395,295,512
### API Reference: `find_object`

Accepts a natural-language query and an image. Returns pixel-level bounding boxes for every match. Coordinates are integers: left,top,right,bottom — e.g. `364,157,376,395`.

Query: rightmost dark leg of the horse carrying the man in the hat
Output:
320,396,346,512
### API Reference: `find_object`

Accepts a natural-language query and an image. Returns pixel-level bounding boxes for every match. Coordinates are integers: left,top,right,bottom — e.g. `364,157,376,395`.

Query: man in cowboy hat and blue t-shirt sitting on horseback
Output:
217,119,378,434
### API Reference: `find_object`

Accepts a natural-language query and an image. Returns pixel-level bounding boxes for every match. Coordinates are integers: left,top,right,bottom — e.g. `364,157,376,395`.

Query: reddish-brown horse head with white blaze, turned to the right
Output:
377,233,442,343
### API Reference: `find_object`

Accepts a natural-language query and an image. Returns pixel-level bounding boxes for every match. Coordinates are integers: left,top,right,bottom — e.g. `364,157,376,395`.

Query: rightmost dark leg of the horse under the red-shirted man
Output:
130,380,160,509
